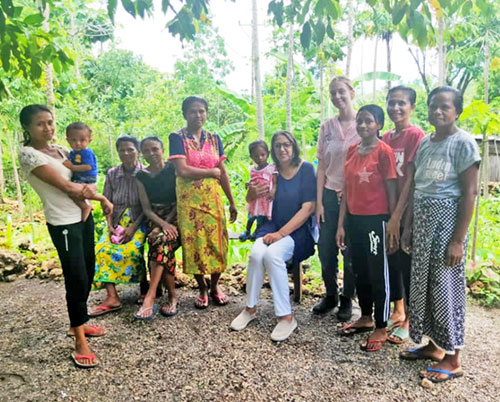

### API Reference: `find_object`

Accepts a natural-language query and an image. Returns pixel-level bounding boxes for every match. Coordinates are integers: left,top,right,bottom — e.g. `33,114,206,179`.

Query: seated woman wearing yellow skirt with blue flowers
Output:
90,135,146,317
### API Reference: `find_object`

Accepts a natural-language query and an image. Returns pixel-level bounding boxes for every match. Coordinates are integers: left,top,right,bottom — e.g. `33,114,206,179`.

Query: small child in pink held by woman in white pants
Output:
240,140,278,241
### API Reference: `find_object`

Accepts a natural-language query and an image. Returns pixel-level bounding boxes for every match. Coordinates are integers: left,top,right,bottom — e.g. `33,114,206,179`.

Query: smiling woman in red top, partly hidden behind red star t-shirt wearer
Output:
382,86,425,344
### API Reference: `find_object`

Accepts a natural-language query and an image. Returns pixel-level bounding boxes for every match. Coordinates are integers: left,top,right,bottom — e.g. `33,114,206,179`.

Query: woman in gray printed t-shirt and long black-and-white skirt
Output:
401,87,481,382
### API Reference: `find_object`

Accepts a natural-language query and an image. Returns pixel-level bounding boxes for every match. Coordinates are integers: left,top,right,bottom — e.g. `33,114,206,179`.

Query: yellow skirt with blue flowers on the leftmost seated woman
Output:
93,210,146,289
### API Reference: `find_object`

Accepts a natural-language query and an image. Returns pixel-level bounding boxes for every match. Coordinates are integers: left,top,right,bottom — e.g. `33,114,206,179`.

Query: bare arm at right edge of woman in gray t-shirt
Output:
445,163,479,267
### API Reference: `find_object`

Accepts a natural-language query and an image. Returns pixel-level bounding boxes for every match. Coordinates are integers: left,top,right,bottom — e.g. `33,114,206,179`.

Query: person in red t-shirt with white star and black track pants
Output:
337,105,397,352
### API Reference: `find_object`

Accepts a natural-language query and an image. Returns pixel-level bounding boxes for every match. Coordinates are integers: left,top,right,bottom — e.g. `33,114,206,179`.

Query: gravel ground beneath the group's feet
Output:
0,279,500,402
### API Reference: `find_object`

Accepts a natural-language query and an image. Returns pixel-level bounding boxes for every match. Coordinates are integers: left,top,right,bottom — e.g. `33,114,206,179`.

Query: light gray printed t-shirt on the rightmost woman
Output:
414,129,481,199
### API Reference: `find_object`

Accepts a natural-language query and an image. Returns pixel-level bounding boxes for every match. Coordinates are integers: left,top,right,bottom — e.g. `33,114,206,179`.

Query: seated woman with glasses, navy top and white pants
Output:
231,131,316,342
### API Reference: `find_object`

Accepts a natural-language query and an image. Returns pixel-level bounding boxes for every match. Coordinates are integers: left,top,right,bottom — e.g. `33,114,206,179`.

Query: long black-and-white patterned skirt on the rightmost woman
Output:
410,196,467,354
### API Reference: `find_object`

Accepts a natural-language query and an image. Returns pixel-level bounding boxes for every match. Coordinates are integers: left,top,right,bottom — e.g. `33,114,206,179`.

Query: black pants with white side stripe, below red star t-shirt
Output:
347,215,390,328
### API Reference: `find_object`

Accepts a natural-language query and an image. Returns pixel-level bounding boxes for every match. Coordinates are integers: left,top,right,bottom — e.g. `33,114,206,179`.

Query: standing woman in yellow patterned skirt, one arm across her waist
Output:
169,96,237,309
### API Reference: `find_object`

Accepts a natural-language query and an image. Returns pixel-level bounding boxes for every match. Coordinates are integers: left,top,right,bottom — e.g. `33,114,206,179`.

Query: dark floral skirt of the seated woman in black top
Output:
148,203,181,275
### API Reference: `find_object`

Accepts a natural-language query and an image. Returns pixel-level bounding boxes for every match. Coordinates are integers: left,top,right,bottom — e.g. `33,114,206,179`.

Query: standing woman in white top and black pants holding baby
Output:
19,105,113,368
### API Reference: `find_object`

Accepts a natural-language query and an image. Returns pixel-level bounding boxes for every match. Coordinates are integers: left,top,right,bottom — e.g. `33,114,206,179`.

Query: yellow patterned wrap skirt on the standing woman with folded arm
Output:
176,177,228,275
